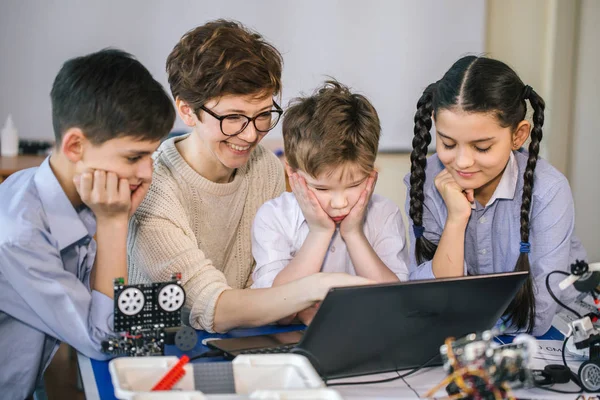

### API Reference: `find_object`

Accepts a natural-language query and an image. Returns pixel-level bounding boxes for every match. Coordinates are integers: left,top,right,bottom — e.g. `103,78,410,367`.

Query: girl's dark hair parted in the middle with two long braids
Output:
409,56,545,332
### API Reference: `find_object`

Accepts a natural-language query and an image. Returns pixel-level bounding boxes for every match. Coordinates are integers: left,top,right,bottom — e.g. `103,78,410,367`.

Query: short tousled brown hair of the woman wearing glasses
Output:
167,19,283,112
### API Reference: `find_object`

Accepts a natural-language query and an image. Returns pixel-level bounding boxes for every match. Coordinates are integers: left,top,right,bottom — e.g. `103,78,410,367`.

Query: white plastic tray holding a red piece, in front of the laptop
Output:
108,354,341,400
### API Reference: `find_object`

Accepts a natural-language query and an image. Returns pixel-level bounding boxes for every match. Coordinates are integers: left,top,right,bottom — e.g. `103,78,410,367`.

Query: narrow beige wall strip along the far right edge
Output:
569,0,600,261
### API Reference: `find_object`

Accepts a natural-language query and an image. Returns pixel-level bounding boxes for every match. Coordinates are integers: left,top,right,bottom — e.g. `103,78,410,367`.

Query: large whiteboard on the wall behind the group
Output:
0,0,486,151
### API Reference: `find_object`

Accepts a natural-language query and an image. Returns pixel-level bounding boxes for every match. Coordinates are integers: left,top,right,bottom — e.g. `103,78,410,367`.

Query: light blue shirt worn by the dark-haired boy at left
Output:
0,159,114,399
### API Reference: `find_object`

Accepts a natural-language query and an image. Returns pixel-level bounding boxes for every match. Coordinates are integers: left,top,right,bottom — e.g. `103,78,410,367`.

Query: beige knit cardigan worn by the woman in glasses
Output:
127,136,285,332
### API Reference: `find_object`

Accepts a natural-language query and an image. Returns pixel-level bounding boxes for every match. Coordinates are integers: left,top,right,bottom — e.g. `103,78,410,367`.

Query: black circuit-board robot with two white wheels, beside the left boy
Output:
102,274,192,356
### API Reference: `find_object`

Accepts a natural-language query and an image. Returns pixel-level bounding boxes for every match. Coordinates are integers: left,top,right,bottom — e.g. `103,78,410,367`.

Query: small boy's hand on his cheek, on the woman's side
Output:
290,173,335,237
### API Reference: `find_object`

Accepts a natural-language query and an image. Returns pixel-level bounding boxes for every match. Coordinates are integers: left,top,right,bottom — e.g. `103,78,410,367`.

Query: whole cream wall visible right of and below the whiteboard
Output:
376,0,600,261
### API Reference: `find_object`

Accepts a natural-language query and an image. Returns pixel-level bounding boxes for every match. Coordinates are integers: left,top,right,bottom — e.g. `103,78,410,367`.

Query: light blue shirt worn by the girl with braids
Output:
404,149,586,336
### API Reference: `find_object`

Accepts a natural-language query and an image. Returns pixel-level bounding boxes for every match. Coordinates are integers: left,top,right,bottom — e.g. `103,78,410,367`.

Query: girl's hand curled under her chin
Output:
434,169,475,223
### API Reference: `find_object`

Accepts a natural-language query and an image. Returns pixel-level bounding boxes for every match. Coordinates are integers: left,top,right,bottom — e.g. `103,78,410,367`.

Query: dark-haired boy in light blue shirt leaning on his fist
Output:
0,49,175,399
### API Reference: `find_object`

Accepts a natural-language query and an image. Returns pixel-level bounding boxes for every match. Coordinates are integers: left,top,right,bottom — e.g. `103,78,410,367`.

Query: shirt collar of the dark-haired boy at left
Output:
34,157,96,251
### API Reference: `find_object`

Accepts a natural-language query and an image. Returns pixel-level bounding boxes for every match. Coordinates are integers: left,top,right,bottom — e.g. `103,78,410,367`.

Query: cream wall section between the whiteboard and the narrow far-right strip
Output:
486,0,579,175
